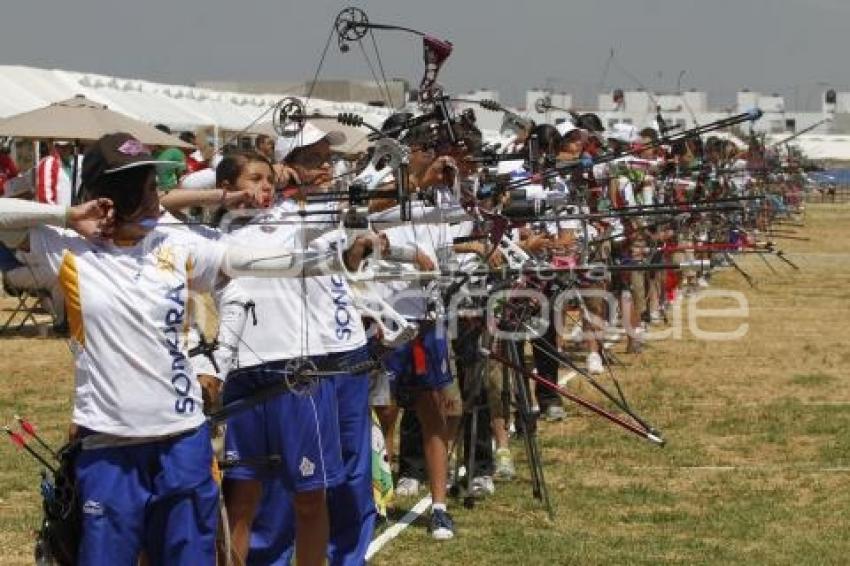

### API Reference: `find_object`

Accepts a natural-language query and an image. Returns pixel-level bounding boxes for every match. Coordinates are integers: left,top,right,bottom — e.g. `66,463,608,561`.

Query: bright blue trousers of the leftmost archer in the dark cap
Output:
76,425,219,566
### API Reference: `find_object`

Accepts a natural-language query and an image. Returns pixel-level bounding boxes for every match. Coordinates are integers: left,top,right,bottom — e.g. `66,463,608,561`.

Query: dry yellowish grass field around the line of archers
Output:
0,205,850,566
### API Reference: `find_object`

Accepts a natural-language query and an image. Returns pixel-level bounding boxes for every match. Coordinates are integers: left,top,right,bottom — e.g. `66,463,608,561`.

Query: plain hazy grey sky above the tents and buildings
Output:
0,0,850,109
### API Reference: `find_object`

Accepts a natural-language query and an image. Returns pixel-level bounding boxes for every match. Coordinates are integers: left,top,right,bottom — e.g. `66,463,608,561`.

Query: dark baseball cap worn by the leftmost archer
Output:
81,132,182,185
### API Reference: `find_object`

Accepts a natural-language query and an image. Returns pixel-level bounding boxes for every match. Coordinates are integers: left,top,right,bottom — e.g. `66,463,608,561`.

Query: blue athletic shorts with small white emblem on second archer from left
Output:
223,348,368,492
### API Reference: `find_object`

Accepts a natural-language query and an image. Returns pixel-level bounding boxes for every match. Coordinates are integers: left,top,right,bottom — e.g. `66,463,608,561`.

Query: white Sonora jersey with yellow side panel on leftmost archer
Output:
30,227,224,437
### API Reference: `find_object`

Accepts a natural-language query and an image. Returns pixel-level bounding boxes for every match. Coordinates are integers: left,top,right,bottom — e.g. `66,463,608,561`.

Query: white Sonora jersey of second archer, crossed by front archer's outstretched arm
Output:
224,201,366,367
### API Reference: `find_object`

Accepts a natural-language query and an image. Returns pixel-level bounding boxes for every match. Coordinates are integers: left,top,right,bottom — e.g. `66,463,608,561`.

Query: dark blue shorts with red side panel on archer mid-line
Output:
384,326,452,399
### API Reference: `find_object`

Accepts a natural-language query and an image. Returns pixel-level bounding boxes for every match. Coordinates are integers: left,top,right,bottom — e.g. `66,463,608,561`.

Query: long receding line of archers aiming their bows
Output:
0,10,802,565
